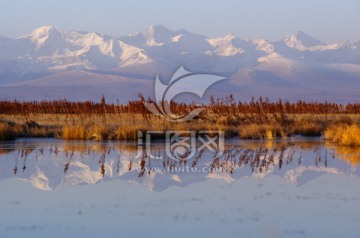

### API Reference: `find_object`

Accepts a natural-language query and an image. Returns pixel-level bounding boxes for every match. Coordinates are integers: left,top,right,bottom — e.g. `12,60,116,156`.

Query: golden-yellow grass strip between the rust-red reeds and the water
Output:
0,113,360,141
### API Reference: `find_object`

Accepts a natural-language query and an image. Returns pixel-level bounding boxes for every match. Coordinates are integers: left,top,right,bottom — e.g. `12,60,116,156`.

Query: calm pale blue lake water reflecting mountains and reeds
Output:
0,138,360,238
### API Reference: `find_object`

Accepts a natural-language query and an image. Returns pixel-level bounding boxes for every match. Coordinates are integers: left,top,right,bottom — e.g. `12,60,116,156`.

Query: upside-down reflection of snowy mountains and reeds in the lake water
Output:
0,139,360,191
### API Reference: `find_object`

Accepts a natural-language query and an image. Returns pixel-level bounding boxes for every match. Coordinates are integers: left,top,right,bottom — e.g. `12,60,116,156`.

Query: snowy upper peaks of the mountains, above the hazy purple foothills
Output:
0,25,360,87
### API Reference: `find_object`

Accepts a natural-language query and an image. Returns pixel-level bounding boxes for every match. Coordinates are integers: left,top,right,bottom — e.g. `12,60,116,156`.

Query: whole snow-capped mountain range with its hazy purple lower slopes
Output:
0,25,360,102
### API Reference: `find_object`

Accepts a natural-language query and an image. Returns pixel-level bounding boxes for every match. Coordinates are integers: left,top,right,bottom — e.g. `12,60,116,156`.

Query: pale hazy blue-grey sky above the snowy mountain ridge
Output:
0,0,360,42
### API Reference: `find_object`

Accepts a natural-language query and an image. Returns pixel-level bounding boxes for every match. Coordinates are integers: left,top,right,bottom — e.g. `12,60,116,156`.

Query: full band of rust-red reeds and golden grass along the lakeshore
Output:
0,96,360,142
